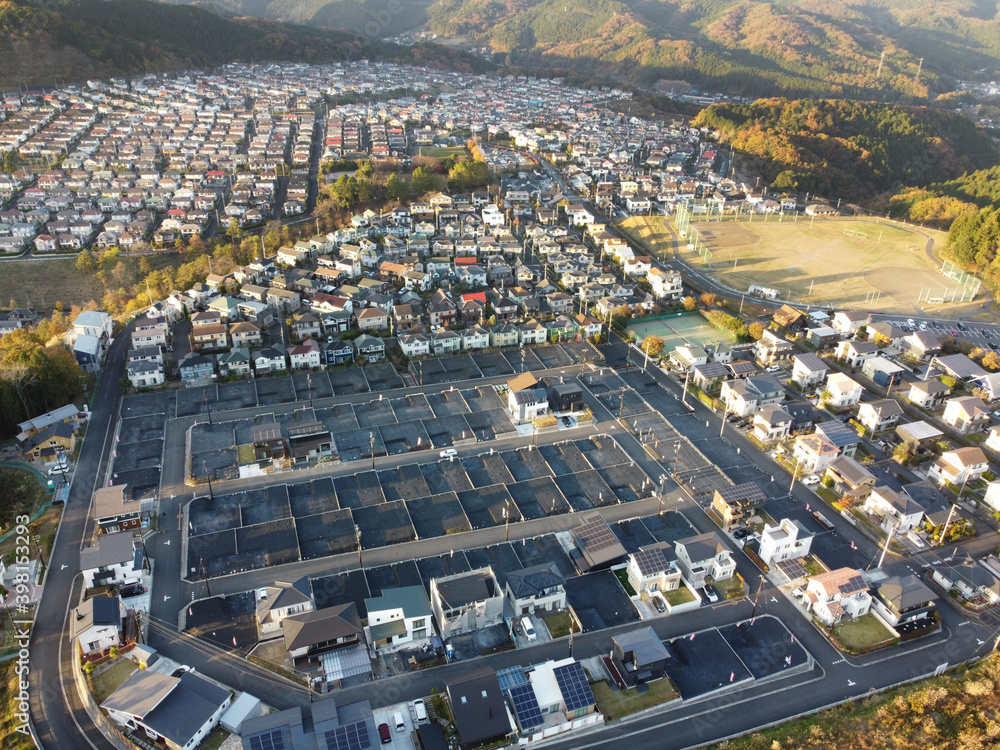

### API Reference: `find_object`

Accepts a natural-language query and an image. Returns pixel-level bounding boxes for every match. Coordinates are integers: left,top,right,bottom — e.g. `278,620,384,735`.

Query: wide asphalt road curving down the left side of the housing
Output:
29,325,132,750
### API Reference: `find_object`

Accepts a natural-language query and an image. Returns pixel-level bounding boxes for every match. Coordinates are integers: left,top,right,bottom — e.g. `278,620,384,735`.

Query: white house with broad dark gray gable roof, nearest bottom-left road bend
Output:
101,669,233,750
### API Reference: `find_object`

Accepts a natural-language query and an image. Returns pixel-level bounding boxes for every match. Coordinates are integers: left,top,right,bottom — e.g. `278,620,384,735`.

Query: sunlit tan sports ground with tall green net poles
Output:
622,216,964,315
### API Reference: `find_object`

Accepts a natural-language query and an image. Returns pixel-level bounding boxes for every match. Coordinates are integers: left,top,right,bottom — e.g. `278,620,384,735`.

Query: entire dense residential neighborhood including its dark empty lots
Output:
0,61,1000,750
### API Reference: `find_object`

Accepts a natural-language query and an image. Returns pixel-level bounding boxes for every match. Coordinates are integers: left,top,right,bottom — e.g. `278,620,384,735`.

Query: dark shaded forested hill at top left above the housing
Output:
0,0,491,89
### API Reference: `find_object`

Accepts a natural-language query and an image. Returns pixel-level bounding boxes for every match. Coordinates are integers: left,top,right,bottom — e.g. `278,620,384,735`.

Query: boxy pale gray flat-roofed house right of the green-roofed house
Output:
430,567,504,640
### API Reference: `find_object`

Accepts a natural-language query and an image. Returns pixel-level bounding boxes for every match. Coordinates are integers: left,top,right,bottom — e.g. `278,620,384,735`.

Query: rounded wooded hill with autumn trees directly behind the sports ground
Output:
695,99,1000,202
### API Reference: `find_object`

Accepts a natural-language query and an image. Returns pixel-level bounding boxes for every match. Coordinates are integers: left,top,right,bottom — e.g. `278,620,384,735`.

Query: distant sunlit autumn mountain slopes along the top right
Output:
418,0,1000,99
